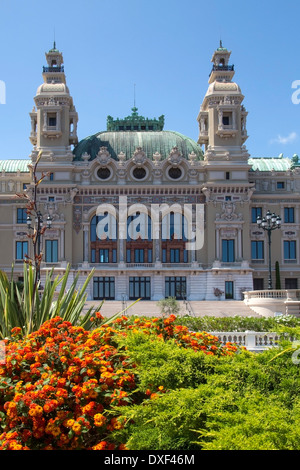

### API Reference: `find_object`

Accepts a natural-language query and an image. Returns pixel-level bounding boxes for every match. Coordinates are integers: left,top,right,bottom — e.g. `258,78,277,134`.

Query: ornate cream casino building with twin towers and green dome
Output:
0,43,300,300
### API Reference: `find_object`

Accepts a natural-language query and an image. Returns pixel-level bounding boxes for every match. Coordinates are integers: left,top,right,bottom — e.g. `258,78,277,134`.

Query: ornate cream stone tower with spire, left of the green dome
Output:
30,41,78,161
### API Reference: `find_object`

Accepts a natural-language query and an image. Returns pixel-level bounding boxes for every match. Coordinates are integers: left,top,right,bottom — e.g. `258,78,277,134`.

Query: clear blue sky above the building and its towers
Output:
0,0,300,159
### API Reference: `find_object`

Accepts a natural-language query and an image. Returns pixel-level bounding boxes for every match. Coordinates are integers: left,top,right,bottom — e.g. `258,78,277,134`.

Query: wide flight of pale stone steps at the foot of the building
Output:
85,300,261,317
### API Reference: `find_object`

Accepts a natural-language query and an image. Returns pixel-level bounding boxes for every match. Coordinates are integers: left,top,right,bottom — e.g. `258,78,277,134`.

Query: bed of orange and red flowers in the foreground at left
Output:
0,314,237,450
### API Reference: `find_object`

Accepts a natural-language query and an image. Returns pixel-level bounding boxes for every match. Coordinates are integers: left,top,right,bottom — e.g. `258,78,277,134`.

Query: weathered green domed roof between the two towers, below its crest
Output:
73,130,203,161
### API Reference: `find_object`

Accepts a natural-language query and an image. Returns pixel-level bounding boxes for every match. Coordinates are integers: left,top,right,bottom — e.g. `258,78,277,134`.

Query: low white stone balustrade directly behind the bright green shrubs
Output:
209,331,280,352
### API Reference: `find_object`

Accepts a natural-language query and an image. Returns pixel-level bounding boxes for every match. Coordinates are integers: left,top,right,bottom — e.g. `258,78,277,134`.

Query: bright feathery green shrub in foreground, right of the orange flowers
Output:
113,329,300,450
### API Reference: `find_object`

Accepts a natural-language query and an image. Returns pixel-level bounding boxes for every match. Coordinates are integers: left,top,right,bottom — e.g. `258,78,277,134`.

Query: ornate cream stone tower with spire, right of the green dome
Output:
197,41,249,178
